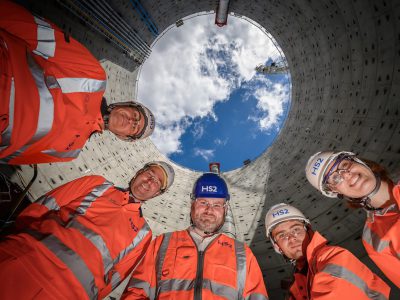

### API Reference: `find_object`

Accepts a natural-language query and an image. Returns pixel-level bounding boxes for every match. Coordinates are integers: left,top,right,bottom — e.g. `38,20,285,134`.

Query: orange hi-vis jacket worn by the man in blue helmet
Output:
122,230,268,300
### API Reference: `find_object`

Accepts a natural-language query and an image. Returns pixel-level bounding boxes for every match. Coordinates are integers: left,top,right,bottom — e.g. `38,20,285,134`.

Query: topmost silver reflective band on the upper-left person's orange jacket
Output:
33,17,56,59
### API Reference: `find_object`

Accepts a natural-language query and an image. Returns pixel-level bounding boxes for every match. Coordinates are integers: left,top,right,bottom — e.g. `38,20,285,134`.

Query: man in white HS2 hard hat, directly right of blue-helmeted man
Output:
265,203,390,300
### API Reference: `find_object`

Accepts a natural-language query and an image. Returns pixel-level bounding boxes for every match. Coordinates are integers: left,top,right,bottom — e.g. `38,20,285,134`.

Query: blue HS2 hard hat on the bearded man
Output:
190,173,230,200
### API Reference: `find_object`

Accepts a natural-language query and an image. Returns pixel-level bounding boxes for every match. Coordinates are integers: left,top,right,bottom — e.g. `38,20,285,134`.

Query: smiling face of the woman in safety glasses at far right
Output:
327,161,376,198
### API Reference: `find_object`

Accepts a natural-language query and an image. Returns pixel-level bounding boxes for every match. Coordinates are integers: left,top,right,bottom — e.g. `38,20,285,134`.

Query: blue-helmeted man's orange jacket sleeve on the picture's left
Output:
121,235,164,300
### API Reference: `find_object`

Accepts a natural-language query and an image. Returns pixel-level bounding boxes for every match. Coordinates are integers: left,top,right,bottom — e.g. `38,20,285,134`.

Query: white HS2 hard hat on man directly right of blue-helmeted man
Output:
265,203,310,242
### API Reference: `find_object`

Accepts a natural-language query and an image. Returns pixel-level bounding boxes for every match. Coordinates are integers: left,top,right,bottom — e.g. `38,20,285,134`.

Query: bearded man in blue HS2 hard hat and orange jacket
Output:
122,173,268,300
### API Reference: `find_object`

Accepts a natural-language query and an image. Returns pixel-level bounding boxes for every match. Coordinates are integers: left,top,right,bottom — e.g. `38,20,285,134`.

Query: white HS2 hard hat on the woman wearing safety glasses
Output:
305,151,358,198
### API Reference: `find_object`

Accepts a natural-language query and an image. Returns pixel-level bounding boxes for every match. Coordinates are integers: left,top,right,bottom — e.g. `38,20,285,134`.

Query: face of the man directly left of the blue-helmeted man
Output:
130,166,165,201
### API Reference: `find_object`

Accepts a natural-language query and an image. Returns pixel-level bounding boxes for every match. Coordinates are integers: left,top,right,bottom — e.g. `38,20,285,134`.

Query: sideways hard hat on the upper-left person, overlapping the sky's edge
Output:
107,101,156,142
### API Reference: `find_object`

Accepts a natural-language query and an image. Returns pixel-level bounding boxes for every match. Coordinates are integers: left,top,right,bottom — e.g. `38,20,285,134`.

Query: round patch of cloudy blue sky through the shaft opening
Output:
138,14,290,171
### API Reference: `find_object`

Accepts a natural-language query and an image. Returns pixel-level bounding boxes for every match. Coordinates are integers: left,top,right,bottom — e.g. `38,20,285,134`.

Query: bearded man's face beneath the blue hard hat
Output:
190,198,227,233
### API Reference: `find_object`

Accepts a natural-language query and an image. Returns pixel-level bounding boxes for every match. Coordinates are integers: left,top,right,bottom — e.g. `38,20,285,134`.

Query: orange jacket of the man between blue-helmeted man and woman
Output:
290,232,390,300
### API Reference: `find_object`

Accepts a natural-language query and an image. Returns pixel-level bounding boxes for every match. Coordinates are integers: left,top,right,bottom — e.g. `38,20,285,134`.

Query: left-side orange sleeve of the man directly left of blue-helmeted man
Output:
16,176,111,228
